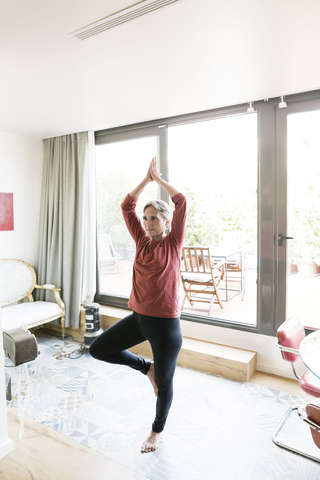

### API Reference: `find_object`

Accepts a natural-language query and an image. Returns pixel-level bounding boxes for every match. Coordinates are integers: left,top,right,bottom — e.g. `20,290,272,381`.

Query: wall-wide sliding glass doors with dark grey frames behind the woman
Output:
96,92,320,335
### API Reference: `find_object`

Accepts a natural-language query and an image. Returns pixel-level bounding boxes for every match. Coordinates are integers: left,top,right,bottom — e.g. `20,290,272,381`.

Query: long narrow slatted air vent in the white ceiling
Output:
69,0,185,40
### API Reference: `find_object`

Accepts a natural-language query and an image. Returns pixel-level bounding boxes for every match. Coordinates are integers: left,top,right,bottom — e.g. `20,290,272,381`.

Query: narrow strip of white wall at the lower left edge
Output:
0,308,14,459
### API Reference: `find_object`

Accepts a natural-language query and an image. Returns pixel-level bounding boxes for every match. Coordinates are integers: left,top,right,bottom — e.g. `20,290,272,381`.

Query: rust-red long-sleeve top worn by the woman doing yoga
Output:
121,193,187,318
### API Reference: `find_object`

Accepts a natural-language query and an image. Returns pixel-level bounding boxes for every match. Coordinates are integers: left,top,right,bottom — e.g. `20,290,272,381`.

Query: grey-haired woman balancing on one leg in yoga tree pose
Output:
90,158,186,452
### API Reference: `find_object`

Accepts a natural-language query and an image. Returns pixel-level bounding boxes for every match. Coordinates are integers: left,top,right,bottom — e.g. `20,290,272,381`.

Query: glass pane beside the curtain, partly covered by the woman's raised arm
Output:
96,136,157,297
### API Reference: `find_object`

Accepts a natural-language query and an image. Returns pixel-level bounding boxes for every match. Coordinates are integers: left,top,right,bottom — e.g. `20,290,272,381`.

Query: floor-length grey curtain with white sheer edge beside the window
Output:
38,132,96,328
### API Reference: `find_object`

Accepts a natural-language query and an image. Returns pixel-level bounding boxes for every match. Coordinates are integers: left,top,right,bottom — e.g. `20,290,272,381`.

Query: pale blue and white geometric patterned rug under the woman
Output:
6,335,320,480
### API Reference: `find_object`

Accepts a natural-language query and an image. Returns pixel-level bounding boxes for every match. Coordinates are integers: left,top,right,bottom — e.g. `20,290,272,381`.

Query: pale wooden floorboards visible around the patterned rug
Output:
0,372,303,480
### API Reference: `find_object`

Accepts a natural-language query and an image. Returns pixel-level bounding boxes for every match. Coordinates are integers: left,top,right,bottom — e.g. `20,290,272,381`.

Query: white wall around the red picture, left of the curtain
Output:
0,132,42,267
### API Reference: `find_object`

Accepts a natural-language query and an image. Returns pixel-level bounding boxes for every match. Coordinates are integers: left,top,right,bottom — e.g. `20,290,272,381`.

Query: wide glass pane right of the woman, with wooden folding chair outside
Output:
168,114,258,325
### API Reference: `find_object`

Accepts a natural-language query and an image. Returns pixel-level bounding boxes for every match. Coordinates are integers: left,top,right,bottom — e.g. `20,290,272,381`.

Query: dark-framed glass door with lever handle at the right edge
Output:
277,101,320,328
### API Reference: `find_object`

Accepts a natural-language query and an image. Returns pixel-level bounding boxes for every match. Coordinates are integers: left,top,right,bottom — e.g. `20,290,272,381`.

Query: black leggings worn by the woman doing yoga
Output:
90,312,182,432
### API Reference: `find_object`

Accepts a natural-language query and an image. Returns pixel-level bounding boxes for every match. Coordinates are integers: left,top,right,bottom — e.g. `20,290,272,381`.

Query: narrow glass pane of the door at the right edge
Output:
286,111,320,326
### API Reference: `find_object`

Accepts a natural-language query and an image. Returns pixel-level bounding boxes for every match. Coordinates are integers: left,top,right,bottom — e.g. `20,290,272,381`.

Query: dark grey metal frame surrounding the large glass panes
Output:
95,90,320,336
